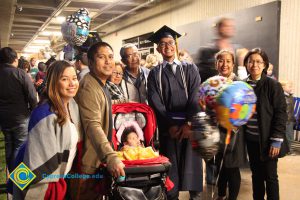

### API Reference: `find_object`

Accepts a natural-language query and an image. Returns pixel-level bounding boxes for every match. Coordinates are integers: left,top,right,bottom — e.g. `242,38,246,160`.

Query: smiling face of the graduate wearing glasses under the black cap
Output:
157,37,176,62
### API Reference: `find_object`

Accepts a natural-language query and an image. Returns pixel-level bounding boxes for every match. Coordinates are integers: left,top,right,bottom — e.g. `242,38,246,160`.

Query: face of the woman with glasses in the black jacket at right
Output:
247,53,266,80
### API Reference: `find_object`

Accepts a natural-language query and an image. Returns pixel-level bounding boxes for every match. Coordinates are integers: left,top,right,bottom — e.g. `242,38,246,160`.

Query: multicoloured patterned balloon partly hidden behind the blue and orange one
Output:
199,76,232,109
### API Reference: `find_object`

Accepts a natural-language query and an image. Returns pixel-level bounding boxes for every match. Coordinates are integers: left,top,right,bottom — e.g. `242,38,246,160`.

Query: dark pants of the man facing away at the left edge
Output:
2,120,28,173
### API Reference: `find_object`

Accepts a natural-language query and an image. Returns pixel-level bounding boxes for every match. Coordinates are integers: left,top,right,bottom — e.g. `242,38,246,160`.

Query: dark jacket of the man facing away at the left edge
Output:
0,64,37,128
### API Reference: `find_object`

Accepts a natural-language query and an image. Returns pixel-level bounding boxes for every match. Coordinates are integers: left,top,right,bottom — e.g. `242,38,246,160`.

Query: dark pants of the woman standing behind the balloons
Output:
218,166,241,200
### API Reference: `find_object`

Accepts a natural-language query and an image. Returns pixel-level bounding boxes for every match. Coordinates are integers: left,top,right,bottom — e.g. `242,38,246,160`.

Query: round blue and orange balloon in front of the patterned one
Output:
215,81,256,130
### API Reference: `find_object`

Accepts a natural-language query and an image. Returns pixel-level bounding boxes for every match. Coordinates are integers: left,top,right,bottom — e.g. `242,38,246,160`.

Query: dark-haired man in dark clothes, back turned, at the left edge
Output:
0,47,37,172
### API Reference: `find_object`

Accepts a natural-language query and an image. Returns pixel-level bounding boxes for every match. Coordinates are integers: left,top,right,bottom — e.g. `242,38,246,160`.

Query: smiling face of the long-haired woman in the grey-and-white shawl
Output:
57,66,79,102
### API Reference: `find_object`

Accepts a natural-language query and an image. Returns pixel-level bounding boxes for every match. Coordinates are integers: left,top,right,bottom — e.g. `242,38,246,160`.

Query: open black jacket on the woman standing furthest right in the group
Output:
246,73,288,160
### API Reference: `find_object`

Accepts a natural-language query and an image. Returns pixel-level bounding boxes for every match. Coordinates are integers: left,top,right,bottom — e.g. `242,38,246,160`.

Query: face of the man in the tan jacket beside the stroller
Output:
91,46,115,80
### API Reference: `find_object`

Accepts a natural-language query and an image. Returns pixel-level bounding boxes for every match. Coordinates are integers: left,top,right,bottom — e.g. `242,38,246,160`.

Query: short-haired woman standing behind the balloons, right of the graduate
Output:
215,50,247,200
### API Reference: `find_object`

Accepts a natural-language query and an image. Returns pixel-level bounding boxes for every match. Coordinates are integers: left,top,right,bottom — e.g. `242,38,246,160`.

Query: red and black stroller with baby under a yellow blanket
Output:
111,103,171,200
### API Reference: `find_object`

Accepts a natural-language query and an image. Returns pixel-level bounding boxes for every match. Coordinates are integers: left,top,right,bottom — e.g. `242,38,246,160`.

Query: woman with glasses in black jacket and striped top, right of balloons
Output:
244,48,288,200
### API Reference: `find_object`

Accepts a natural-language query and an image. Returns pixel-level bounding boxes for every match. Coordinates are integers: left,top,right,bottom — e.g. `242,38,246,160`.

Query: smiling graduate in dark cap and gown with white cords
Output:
148,26,203,200
